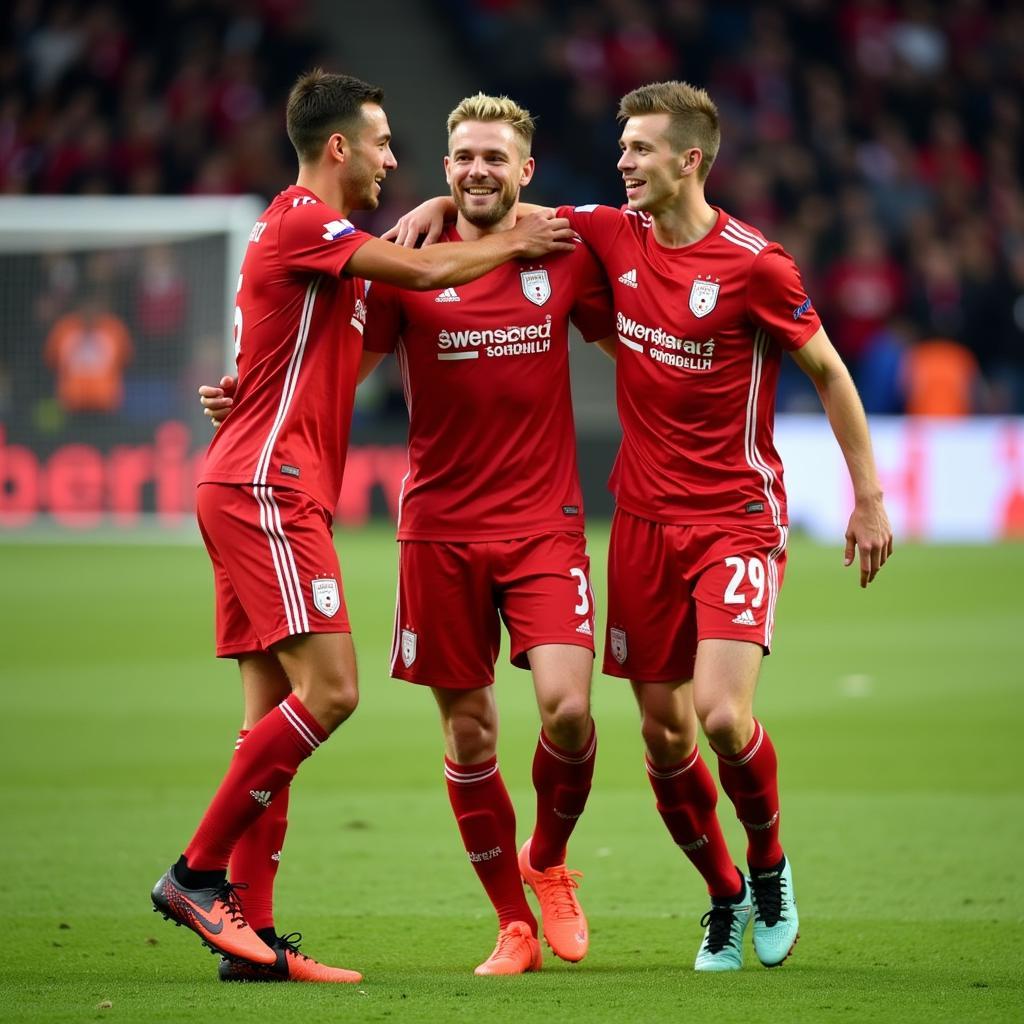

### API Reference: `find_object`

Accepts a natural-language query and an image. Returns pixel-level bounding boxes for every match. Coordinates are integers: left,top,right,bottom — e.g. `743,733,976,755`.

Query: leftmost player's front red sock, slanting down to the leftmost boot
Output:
184,693,328,881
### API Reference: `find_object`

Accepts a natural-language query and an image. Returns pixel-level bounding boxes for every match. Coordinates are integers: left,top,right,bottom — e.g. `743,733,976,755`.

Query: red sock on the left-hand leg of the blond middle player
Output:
444,758,537,935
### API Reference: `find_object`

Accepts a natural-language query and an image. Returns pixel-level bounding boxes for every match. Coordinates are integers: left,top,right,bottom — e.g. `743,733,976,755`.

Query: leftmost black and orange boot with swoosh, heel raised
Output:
153,867,276,964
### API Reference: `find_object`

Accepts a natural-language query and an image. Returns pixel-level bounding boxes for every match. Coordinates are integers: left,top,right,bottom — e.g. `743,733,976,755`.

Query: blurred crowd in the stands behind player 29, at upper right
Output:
444,0,1024,415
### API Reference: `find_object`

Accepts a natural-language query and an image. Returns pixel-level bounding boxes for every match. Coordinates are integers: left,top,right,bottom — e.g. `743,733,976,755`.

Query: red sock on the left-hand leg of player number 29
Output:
647,746,739,899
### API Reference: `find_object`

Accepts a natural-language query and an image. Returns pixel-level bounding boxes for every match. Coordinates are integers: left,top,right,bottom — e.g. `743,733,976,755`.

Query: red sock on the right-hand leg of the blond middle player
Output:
529,723,597,871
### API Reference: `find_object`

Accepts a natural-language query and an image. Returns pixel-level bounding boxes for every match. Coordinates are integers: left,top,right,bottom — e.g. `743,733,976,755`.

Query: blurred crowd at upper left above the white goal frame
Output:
0,0,324,196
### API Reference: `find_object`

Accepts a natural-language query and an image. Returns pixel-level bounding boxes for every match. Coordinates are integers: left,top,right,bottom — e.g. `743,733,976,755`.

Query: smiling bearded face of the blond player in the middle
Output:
444,121,534,227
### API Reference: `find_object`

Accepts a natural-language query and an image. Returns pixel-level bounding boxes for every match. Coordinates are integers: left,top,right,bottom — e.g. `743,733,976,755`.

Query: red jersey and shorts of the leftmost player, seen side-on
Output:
198,185,373,656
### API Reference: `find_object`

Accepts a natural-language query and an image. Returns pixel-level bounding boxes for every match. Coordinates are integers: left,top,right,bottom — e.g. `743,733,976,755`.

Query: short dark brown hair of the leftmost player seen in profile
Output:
286,68,384,163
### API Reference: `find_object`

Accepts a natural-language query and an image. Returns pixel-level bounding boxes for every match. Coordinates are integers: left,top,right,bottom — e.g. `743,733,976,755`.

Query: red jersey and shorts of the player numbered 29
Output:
558,206,821,681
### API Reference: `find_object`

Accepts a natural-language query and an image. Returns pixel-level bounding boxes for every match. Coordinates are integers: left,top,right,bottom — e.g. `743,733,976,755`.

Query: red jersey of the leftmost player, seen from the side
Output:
200,185,373,512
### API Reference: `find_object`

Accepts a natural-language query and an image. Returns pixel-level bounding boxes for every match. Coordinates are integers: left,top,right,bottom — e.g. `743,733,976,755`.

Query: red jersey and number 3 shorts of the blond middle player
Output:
364,227,613,688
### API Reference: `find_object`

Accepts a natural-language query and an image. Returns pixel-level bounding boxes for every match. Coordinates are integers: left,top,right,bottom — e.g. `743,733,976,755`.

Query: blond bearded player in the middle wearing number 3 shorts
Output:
202,94,613,975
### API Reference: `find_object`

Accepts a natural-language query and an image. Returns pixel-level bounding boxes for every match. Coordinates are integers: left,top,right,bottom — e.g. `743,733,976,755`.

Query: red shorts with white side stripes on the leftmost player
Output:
196,483,351,657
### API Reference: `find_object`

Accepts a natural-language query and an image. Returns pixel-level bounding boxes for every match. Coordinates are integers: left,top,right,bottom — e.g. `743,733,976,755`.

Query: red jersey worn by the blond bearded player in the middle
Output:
365,227,614,542
